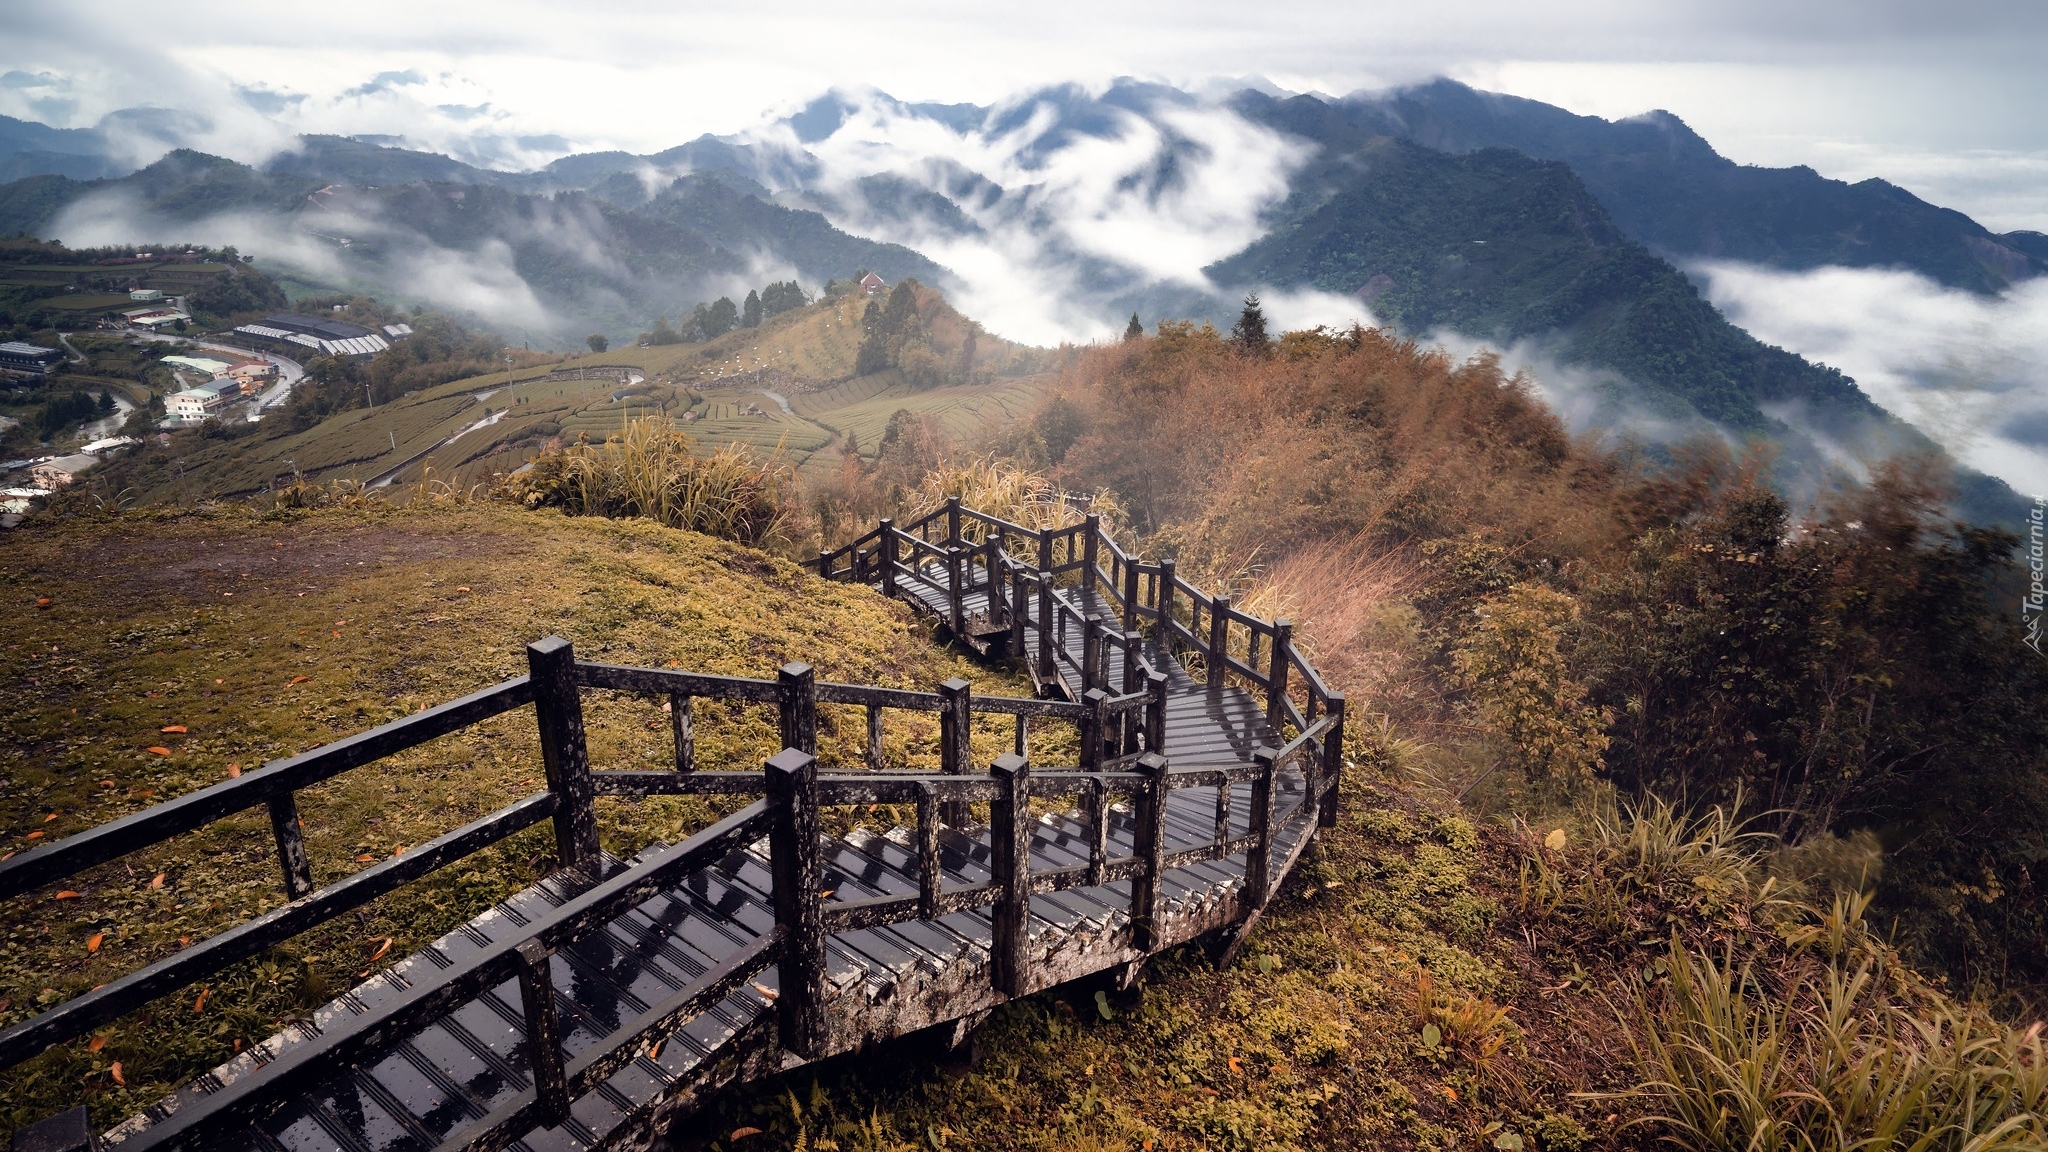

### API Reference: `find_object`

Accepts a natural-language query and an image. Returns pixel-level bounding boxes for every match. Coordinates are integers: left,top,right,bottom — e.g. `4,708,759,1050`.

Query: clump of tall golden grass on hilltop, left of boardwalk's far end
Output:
502,416,799,545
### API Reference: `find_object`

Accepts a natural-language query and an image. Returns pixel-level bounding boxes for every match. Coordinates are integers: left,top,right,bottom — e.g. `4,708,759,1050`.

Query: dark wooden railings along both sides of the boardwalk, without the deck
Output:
12,502,1343,1152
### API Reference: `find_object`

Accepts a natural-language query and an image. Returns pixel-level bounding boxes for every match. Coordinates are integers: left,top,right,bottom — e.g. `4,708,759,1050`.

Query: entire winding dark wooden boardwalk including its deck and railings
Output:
12,502,1343,1152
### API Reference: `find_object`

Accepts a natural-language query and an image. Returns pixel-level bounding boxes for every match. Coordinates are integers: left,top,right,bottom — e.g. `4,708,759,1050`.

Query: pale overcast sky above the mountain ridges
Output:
12,0,2048,230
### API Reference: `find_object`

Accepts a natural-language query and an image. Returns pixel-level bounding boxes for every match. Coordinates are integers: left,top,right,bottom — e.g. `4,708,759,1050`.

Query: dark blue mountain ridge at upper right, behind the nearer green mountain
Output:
1261,80,2048,291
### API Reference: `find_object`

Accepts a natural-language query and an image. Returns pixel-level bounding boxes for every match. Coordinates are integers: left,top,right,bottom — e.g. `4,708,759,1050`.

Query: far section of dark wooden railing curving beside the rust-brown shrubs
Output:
807,496,1343,826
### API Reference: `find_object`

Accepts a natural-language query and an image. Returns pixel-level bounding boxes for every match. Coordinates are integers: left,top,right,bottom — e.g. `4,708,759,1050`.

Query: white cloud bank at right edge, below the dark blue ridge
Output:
1694,262,2048,492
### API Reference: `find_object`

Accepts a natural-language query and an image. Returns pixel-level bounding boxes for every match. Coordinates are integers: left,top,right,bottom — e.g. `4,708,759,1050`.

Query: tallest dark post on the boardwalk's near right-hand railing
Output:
766,748,825,1060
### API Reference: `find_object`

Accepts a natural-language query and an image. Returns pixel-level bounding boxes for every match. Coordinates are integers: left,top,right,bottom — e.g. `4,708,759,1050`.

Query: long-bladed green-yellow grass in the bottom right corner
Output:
1522,801,2048,1152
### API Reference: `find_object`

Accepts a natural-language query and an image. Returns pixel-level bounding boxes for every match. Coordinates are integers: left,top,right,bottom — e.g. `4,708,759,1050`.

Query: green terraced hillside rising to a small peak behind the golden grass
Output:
90,289,1049,502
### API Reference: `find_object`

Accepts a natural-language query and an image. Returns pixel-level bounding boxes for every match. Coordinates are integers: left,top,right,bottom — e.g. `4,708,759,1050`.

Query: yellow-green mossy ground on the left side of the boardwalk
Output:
0,506,1071,1132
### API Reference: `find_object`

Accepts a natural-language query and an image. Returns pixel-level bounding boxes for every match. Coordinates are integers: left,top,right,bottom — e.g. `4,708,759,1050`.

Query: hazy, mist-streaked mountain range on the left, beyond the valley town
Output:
0,147,946,340
